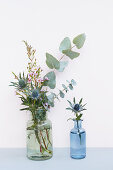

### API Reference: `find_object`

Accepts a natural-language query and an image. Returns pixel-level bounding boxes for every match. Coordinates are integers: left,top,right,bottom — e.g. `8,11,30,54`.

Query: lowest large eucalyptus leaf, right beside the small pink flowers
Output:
44,71,56,89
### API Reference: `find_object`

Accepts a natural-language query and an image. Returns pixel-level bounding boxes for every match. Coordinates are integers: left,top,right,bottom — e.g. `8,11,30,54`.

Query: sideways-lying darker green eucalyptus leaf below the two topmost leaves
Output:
63,50,80,60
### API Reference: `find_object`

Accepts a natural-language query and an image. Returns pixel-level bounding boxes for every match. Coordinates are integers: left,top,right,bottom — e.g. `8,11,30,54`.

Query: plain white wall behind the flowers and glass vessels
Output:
0,0,113,147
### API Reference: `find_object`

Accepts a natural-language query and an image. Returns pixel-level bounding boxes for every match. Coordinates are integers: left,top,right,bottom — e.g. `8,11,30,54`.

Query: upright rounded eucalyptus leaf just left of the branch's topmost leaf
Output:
59,37,71,52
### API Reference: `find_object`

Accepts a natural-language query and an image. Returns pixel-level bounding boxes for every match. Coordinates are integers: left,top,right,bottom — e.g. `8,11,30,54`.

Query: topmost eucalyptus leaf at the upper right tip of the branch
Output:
73,34,86,49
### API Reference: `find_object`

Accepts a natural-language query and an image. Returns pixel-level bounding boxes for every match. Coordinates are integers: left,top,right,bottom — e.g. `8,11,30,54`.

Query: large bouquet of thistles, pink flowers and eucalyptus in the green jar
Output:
11,34,85,159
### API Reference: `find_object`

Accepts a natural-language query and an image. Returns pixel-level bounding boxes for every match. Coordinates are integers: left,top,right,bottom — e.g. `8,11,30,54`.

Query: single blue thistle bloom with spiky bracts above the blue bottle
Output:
66,97,86,121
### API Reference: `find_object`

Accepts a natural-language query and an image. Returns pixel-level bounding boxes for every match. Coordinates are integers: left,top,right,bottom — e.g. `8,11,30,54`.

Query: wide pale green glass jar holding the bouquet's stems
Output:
27,112,53,161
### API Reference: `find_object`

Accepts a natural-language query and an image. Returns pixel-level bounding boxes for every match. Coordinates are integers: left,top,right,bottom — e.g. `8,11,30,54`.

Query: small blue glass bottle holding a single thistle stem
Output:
70,120,86,159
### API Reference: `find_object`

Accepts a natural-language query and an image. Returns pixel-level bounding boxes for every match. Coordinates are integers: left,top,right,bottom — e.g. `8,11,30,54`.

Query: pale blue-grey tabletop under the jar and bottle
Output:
0,148,113,170
